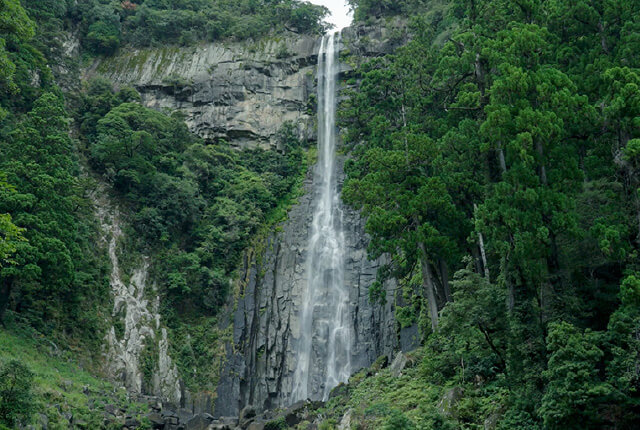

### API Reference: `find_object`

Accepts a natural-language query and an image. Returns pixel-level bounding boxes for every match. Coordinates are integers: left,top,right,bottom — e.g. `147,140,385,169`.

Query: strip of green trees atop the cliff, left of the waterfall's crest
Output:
23,0,327,55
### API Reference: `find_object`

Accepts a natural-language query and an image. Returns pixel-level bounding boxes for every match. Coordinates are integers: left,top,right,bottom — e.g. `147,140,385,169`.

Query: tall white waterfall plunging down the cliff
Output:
291,34,351,401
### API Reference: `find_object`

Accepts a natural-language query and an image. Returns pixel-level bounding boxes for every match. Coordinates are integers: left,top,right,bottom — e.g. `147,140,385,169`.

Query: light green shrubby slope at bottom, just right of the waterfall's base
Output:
312,349,504,430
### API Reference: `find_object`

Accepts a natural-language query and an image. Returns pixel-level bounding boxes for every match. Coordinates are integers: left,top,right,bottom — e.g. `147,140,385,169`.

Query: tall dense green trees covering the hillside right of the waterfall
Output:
341,0,640,429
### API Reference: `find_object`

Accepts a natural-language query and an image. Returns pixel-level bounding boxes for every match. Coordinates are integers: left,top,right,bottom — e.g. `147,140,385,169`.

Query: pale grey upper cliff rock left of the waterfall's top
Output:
85,35,318,148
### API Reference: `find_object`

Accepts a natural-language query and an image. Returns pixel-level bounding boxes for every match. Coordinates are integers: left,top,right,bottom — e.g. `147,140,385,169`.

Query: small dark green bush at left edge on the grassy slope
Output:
0,360,33,426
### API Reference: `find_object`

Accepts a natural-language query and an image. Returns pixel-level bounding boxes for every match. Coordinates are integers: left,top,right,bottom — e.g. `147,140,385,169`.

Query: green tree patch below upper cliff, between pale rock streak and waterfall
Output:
78,80,306,370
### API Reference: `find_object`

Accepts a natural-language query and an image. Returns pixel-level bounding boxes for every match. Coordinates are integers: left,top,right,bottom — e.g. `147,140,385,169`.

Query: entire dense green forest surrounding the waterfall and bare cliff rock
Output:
0,0,640,430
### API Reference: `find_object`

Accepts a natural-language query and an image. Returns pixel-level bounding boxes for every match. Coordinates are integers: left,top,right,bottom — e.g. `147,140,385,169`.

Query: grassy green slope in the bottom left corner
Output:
0,330,146,430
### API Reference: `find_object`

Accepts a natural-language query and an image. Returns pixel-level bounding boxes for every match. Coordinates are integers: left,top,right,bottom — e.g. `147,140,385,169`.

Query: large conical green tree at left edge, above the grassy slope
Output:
0,93,105,336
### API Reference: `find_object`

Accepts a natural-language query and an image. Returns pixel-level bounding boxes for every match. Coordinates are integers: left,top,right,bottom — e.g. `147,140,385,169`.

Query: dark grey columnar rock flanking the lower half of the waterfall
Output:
215,156,399,416
